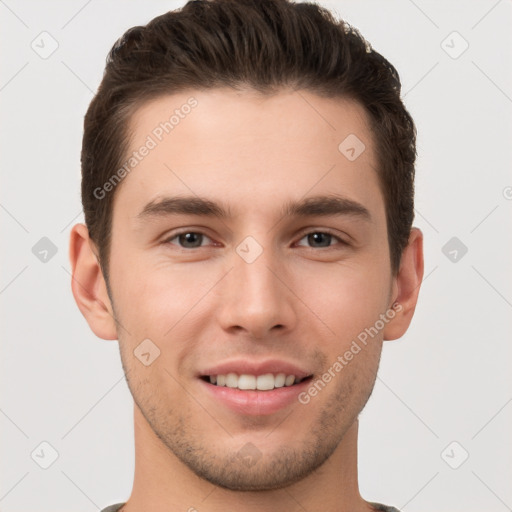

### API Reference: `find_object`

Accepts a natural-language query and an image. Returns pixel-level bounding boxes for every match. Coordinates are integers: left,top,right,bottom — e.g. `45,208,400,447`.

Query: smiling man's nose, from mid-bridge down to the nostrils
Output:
217,240,297,339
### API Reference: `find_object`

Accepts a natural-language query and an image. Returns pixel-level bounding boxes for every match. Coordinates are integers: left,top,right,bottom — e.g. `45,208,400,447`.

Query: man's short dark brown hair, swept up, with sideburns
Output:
81,0,416,284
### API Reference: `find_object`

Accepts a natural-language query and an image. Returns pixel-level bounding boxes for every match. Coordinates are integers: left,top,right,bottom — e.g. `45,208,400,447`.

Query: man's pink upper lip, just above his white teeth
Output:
198,359,311,379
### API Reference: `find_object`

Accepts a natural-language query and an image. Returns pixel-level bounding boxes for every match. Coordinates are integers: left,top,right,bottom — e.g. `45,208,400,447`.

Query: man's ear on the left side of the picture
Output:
69,224,117,340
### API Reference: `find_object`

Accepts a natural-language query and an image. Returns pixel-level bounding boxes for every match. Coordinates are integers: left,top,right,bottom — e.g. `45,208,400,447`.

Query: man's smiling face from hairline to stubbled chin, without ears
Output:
109,89,394,490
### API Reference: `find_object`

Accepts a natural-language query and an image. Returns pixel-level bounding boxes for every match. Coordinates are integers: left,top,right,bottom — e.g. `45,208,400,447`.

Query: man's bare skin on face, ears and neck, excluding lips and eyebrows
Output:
70,89,423,512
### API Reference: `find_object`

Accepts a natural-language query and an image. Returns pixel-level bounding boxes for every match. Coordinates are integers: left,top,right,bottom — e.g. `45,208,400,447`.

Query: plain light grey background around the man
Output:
0,0,512,512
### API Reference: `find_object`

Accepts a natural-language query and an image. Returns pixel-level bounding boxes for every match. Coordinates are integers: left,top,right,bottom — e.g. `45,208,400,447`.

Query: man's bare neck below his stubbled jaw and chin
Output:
122,405,371,512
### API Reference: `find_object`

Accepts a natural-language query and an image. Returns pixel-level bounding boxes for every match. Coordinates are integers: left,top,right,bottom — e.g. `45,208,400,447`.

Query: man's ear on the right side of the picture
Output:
383,228,424,340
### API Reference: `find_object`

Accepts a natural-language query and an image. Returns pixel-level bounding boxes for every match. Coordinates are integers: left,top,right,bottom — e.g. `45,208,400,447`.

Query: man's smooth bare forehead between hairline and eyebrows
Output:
114,89,379,220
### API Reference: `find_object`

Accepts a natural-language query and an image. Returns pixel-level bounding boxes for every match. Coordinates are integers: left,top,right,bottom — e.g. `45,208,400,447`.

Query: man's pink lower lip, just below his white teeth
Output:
199,379,311,416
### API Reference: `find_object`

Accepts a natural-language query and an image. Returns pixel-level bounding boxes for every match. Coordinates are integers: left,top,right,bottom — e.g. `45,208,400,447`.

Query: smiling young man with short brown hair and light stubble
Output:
70,0,423,512
